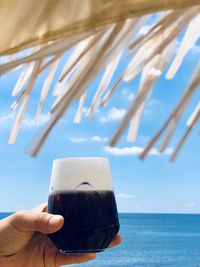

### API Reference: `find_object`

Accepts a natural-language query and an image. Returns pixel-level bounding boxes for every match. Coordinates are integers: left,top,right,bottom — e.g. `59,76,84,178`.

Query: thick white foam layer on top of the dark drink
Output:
50,157,112,193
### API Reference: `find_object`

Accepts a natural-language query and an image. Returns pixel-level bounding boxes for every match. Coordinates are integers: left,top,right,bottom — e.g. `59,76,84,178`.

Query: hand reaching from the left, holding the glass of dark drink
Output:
0,205,121,267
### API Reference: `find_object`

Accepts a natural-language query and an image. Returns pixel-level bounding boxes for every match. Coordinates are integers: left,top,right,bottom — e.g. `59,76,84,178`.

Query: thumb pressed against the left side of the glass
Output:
10,211,64,234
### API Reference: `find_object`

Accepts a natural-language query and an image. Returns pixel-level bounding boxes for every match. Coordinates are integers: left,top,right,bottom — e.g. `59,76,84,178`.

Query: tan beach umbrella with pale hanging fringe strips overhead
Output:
0,0,200,160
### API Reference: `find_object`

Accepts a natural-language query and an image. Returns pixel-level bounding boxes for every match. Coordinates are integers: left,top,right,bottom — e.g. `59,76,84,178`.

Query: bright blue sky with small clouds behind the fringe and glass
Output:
0,37,200,213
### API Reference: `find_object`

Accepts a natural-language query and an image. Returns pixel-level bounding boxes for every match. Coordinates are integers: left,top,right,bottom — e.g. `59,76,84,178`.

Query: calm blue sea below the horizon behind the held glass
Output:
0,213,200,267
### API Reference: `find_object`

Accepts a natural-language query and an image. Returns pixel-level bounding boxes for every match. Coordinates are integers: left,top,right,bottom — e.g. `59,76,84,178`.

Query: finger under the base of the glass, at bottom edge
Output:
55,253,96,267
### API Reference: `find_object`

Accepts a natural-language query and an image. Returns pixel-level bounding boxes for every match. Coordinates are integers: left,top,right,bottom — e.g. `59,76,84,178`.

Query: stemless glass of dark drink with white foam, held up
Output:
48,157,119,253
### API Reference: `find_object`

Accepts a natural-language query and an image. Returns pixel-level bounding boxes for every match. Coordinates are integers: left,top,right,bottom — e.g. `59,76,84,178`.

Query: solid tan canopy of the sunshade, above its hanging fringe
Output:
0,0,200,55
